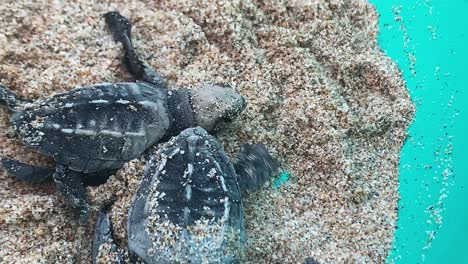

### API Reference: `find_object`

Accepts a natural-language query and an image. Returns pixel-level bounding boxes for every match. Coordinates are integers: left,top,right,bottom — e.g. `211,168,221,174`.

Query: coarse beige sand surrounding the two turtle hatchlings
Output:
0,0,414,263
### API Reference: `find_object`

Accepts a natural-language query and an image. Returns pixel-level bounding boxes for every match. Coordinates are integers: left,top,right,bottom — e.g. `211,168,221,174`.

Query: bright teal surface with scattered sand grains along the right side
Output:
371,0,468,263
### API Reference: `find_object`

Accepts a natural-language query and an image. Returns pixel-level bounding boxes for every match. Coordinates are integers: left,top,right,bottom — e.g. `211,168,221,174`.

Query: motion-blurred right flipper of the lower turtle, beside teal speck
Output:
233,144,279,191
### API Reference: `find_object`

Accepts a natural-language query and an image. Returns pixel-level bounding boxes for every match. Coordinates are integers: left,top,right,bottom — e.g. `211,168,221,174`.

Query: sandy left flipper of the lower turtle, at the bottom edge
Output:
92,205,125,264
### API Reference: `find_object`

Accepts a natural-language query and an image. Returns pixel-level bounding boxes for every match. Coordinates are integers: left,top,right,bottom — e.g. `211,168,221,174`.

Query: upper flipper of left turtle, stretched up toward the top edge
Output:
104,12,167,88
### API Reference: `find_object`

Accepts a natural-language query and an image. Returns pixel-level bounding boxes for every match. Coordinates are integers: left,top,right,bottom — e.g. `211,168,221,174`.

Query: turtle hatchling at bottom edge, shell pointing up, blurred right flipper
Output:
93,127,278,264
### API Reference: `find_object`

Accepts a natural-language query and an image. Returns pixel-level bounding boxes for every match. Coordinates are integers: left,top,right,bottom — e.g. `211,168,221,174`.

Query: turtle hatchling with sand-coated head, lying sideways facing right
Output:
0,12,245,220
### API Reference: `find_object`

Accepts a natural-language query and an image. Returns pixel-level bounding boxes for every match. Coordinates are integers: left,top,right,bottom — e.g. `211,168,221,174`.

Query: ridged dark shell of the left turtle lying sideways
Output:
11,83,170,173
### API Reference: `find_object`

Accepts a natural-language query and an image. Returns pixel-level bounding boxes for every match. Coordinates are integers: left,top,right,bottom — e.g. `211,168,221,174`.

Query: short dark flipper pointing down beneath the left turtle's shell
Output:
53,164,89,223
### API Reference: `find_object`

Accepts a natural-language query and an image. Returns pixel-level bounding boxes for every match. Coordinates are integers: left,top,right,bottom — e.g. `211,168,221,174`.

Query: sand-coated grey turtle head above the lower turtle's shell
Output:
191,84,247,131
